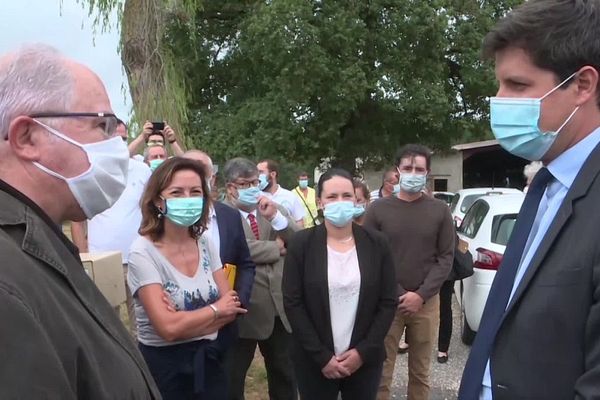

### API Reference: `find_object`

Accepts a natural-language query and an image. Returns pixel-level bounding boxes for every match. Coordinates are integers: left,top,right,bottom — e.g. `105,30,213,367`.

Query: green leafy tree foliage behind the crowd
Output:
79,0,522,169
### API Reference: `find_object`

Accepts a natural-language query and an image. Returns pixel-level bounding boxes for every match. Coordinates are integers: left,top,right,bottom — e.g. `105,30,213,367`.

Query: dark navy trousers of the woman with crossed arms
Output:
138,340,227,400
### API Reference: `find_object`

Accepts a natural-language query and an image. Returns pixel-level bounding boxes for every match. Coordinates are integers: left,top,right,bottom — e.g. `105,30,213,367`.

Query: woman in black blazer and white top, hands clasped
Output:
282,169,396,400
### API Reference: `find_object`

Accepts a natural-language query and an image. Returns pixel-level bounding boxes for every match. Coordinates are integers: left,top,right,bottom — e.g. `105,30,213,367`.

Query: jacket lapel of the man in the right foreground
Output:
504,141,600,317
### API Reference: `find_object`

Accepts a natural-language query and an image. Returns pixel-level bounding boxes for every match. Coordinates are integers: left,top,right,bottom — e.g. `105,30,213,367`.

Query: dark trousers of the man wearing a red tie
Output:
226,318,298,400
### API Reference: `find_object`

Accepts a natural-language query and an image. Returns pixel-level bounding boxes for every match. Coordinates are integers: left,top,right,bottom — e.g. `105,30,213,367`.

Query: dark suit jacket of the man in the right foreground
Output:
491,142,600,400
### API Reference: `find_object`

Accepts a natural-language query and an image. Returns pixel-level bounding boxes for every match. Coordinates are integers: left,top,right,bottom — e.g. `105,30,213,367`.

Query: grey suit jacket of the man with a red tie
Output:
228,203,299,340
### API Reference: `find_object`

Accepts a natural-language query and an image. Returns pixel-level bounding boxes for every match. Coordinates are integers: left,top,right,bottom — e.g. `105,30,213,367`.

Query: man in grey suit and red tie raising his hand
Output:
223,158,299,400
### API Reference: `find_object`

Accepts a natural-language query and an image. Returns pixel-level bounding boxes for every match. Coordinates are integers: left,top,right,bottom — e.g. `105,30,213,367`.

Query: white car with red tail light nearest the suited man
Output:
454,193,525,344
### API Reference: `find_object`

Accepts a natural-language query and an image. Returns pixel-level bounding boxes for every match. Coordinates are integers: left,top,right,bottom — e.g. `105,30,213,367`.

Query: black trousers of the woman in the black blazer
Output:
292,345,383,400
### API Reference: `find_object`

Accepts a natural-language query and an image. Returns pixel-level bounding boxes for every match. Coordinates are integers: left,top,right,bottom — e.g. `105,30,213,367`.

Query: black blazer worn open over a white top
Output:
282,224,397,368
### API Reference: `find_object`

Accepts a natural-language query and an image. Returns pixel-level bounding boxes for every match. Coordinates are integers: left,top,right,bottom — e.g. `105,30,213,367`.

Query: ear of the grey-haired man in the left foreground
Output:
7,116,42,161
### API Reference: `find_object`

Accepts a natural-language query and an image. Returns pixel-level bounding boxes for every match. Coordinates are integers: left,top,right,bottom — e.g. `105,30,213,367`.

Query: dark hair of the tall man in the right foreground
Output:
482,0,600,105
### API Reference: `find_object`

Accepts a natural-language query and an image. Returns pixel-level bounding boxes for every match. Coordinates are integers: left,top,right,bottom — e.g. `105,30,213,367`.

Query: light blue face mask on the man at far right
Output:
490,73,579,161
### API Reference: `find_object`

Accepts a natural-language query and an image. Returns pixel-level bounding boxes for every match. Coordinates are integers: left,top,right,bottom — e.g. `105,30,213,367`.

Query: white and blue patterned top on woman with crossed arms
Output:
127,236,222,346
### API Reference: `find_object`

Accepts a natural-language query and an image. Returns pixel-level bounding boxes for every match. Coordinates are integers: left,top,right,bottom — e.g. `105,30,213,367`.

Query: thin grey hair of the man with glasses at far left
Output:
0,44,75,139
